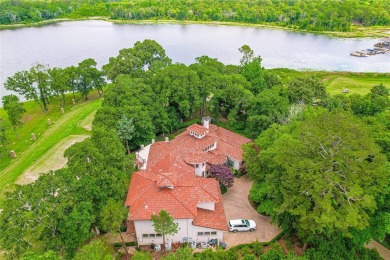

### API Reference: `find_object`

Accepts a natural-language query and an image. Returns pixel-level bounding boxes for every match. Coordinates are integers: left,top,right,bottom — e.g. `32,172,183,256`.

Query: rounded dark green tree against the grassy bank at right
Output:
288,77,326,105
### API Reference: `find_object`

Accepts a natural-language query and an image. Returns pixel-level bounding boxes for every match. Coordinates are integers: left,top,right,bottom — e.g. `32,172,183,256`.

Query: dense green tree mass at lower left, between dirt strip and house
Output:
0,126,131,258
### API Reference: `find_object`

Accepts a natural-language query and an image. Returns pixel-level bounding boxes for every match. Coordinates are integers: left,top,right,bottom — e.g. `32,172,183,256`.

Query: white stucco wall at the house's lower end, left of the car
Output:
134,219,223,245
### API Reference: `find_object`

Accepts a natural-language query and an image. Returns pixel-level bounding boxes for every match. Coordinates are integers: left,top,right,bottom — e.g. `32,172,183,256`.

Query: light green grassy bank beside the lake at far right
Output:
272,69,390,95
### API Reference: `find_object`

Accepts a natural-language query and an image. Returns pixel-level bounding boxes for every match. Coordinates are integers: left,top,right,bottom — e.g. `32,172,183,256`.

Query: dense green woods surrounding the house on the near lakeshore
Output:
0,40,390,259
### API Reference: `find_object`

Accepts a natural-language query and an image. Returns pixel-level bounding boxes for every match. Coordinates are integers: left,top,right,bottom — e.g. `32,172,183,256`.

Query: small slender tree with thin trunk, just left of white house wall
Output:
101,199,130,259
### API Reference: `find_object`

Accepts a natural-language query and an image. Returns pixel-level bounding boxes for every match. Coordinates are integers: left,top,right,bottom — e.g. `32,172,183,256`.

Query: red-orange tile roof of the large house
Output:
126,124,251,230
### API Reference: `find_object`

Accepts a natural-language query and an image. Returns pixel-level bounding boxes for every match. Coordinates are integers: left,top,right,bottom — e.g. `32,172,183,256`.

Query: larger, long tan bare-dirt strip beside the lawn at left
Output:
16,135,88,185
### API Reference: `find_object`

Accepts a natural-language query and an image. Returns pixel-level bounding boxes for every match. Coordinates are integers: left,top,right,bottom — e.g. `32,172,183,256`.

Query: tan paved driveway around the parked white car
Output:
222,176,281,247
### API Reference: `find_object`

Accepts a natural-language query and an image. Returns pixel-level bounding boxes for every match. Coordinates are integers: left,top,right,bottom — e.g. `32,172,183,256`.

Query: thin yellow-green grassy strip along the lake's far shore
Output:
0,16,390,38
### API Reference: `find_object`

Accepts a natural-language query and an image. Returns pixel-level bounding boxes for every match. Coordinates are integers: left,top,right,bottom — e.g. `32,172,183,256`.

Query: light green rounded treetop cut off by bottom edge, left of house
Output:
73,239,113,260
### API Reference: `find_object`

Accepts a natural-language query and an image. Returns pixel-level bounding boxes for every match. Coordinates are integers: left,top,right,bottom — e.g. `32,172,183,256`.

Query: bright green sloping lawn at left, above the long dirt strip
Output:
0,93,101,198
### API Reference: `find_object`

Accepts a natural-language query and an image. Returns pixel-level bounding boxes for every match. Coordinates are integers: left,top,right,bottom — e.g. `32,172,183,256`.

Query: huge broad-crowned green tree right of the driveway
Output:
244,109,389,249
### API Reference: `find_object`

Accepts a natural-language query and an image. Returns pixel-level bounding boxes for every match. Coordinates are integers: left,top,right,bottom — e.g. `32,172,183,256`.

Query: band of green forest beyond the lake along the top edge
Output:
0,0,390,32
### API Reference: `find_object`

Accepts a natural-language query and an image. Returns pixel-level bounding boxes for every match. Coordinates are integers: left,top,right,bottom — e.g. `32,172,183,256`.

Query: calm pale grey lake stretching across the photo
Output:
0,21,390,98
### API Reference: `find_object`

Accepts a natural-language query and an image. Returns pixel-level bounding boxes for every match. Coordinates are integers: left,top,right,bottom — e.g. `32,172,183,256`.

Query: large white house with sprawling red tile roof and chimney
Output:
126,117,251,245
